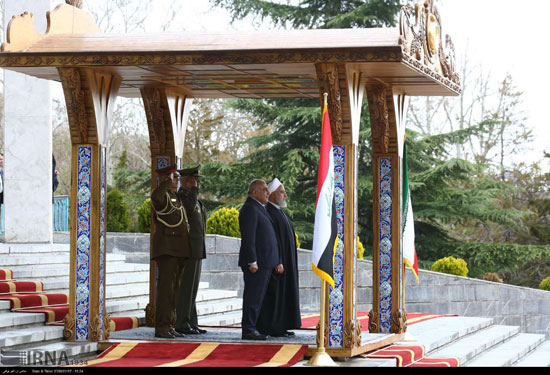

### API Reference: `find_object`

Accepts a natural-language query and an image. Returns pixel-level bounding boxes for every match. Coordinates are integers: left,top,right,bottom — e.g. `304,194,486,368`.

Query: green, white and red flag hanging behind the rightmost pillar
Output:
403,140,419,282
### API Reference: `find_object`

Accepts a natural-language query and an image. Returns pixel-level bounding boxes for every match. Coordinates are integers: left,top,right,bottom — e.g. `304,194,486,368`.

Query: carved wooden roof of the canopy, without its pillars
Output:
0,4,460,98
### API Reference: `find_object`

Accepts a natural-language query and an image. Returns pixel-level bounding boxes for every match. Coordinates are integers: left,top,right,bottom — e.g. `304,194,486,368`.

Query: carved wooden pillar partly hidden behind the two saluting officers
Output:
141,87,190,327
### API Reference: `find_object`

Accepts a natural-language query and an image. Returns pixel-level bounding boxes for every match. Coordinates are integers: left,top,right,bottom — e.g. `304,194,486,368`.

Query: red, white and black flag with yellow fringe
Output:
312,100,338,288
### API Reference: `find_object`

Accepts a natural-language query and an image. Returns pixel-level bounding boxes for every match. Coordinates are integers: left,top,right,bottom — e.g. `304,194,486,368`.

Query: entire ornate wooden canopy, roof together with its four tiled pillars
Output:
0,0,461,357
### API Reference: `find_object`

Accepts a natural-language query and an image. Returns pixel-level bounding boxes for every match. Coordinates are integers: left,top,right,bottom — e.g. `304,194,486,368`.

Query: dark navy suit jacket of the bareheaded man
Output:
239,197,279,268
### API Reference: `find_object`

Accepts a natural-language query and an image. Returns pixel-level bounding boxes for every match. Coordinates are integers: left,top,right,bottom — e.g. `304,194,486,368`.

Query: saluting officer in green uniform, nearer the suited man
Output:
176,165,206,335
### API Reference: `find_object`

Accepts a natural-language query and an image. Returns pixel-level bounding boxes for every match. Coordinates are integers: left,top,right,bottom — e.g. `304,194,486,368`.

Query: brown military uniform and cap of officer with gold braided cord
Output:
151,167,191,338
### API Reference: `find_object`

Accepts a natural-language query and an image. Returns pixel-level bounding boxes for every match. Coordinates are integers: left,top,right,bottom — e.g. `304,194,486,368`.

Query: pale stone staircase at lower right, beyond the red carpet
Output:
399,317,550,367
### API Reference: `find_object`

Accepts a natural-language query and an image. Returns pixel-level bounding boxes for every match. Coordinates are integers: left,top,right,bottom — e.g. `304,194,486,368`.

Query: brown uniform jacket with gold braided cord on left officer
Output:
151,180,191,259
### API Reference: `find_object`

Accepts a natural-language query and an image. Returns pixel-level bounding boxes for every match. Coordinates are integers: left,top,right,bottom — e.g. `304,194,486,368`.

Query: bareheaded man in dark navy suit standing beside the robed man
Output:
239,180,279,340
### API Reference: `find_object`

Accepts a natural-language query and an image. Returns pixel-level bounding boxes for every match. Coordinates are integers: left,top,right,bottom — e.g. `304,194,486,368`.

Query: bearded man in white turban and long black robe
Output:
257,178,302,337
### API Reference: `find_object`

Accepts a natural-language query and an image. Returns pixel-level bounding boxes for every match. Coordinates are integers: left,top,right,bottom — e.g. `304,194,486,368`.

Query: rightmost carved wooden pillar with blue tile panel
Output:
367,83,407,333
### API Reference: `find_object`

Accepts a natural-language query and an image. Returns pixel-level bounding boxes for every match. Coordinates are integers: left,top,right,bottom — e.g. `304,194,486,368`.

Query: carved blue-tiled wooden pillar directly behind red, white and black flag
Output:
316,64,364,356
